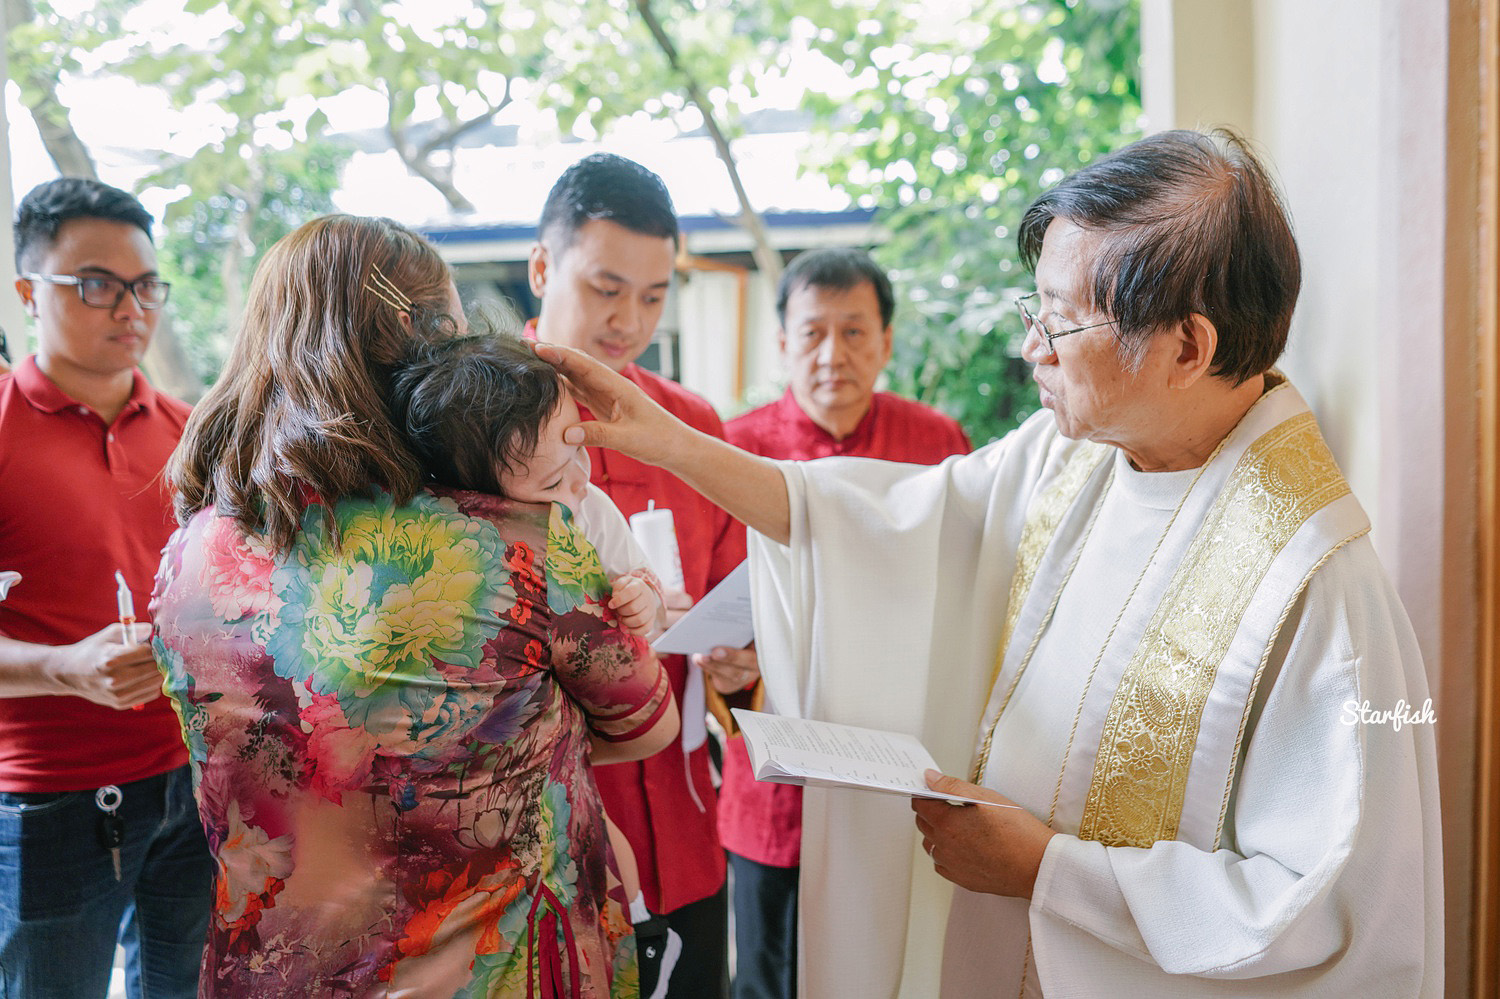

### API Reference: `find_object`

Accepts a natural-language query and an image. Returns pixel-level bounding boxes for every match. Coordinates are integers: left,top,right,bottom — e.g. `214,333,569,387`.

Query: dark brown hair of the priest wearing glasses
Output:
1017,129,1302,386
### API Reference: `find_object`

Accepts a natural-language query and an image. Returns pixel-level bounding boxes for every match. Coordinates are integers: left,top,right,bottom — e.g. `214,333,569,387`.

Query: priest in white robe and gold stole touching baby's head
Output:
545,132,1443,999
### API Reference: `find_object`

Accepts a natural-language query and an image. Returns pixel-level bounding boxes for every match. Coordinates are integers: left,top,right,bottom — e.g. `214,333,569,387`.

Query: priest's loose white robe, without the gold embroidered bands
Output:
752,386,1442,999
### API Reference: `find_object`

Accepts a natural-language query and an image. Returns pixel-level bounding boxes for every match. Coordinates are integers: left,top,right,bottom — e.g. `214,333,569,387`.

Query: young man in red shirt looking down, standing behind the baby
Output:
528,153,746,999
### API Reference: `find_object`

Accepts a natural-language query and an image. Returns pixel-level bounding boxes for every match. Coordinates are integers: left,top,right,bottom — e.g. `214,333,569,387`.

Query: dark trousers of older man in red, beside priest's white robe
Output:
729,854,798,999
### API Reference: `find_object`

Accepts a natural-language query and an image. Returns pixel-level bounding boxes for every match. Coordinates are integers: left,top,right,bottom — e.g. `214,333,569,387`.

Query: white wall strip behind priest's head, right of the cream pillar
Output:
1253,0,1389,528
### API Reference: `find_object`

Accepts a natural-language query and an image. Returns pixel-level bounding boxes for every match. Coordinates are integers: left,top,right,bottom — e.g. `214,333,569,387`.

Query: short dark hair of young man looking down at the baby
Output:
537,153,678,252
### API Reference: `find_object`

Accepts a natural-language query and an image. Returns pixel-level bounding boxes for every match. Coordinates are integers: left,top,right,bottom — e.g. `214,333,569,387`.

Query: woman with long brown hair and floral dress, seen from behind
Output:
152,216,678,999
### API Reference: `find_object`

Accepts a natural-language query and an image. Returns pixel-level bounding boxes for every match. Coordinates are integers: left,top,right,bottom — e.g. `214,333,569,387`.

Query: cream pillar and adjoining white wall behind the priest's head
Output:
1143,0,1382,522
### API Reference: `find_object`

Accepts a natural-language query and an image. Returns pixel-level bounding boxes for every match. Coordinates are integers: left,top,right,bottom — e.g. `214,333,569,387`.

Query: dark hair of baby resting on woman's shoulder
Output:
390,333,563,495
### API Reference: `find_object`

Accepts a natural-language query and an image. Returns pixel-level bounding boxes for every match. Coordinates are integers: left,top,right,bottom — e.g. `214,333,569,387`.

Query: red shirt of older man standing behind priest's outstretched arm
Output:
719,390,969,867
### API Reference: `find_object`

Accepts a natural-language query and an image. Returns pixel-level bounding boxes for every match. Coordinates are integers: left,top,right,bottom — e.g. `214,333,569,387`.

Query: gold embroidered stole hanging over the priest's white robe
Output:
974,386,1368,846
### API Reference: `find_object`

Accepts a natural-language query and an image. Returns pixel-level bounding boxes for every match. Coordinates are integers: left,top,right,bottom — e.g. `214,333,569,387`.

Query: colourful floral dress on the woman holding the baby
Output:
153,492,671,999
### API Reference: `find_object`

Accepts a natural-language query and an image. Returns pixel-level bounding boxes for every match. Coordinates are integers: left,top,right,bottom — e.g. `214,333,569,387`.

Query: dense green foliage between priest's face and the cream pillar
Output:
786,0,1140,443
